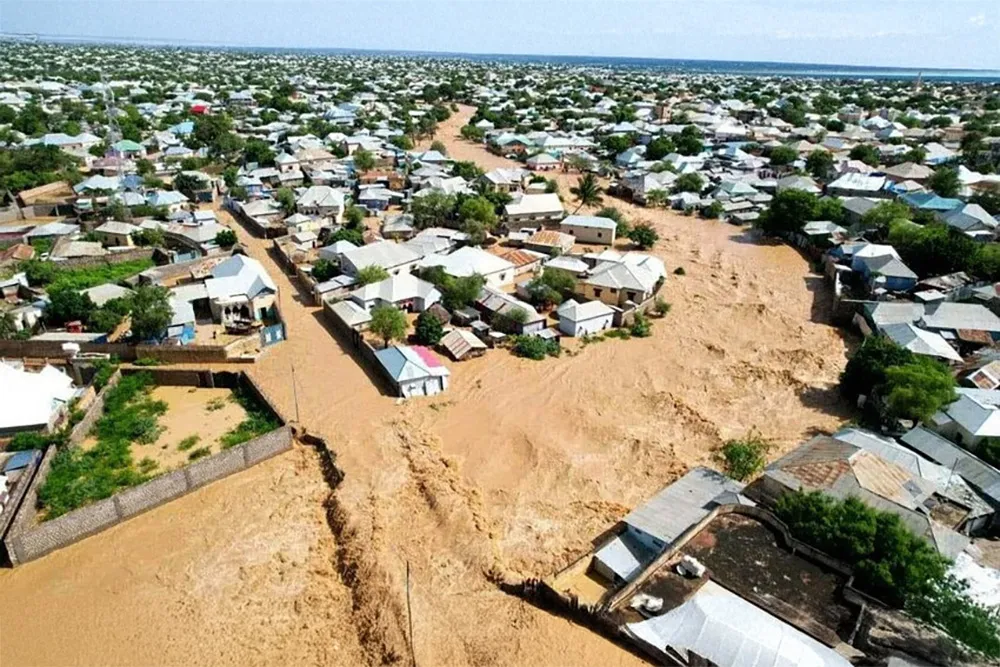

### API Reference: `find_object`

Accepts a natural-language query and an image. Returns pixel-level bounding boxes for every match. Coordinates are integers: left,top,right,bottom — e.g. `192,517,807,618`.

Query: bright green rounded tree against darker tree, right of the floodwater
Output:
885,356,957,421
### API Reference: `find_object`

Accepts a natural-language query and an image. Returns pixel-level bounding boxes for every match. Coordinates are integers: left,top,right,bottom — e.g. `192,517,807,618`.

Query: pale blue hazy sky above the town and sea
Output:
0,0,1000,70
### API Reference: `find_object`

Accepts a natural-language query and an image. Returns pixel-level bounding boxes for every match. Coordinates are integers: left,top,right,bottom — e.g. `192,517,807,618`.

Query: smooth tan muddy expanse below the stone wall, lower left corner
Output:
0,450,363,666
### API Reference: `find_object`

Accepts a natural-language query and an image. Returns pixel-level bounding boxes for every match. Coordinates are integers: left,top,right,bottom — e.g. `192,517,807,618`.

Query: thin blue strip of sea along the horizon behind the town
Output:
0,31,1000,75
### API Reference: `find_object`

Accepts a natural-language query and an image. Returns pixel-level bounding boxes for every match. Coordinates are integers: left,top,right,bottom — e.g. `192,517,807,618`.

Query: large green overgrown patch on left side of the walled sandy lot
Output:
38,373,167,520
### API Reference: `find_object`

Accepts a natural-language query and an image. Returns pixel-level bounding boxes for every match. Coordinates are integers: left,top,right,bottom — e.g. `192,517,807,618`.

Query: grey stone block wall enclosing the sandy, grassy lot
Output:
3,368,293,566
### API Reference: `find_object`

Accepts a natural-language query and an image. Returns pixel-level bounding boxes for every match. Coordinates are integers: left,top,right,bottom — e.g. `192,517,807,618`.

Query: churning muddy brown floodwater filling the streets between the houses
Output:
0,107,848,667
